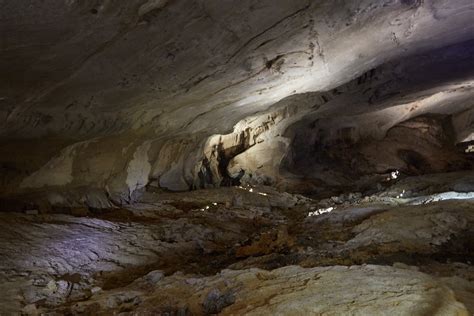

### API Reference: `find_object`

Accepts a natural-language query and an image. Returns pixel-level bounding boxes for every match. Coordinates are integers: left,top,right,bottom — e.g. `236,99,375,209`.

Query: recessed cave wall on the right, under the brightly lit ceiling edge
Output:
214,42,474,191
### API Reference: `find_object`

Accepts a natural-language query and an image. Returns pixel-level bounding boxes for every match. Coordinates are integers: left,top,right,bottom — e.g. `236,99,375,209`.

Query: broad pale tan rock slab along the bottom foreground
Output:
60,265,469,316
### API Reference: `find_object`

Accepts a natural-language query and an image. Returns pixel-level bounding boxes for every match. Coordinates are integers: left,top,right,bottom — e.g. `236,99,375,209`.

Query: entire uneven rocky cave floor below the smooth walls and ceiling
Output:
0,172,474,315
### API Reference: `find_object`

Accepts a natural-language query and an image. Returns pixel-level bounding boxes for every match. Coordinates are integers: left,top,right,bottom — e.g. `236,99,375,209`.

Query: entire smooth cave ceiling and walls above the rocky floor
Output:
0,0,474,208
